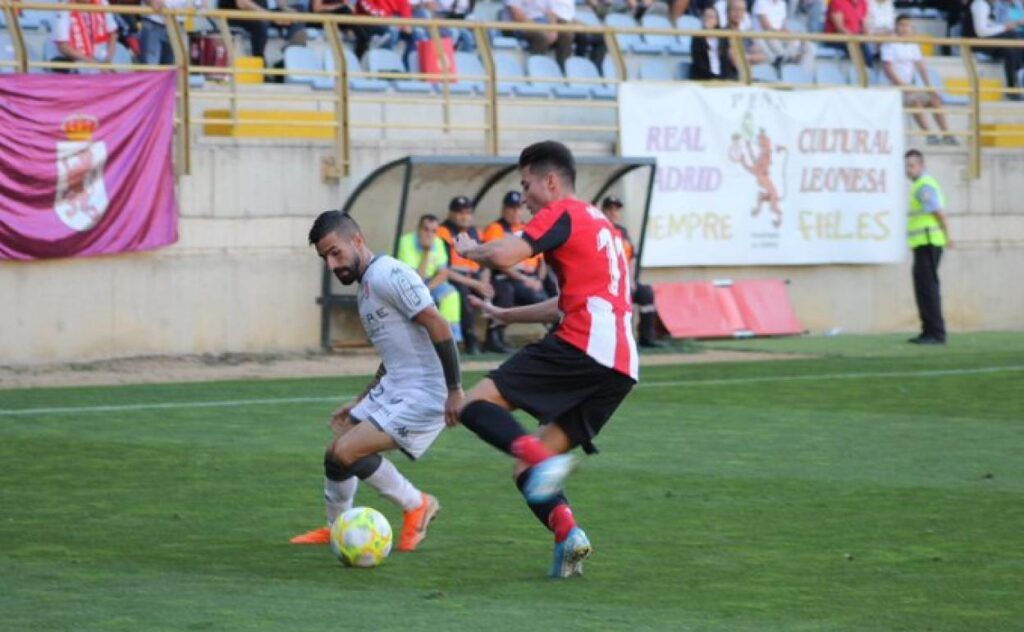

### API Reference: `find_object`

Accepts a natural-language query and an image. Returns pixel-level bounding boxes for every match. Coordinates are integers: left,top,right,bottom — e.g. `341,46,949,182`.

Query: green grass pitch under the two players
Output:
0,334,1024,631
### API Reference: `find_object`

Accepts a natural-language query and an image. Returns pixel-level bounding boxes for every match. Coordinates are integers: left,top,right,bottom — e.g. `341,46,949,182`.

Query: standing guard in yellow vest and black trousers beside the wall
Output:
904,150,951,344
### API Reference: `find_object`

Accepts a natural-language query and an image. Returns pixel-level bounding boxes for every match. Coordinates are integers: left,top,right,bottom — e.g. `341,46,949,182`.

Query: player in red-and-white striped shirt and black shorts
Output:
456,140,638,578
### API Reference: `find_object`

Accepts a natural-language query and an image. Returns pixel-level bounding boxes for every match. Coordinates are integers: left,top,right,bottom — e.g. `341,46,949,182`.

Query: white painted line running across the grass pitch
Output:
0,365,1024,417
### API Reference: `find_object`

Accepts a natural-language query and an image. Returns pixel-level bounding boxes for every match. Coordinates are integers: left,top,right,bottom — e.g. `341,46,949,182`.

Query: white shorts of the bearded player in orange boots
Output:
350,386,444,459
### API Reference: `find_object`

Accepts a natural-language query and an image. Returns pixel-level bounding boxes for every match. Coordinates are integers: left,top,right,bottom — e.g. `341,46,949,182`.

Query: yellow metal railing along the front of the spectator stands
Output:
0,0,1024,177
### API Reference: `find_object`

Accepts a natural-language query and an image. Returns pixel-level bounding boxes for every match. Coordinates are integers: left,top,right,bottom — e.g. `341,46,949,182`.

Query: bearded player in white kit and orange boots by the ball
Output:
292,211,464,551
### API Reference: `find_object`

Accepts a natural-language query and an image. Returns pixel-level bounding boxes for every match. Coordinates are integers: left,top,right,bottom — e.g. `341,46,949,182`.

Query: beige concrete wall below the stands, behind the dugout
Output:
0,138,1024,365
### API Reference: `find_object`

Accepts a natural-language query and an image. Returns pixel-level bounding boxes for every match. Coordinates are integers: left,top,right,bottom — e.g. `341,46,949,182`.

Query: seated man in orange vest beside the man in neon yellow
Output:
437,196,495,355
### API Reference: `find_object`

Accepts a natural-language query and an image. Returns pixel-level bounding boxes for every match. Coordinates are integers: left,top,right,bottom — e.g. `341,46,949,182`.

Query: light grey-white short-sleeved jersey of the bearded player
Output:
356,255,447,409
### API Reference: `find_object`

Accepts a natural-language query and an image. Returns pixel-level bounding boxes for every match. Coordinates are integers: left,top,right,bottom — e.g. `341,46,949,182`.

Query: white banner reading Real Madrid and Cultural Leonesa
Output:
618,83,907,267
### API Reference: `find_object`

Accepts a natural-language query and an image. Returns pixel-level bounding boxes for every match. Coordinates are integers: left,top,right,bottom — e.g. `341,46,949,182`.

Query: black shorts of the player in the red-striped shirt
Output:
487,334,636,454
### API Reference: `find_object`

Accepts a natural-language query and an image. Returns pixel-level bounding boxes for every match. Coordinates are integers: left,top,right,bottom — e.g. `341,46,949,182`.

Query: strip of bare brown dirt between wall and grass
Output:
0,348,803,389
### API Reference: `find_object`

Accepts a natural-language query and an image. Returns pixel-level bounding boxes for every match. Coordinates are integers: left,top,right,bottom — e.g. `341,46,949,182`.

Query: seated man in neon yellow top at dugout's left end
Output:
398,214,462,342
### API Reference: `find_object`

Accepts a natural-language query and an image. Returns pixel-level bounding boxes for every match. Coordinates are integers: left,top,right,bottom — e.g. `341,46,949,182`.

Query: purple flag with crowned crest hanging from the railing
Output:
0,71,178,259
